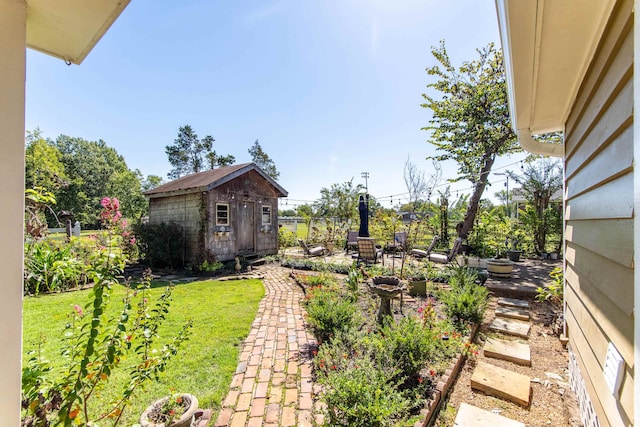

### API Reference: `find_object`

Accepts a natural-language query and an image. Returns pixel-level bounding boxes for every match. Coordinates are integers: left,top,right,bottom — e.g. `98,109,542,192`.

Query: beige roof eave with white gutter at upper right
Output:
496,0,615,157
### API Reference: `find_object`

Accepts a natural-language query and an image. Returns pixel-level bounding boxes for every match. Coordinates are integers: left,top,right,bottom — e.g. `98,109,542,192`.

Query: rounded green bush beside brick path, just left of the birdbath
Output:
306,285,361,343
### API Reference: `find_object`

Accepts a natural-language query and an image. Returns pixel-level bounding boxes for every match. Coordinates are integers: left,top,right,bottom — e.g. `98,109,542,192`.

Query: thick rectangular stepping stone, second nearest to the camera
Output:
471,362,531,407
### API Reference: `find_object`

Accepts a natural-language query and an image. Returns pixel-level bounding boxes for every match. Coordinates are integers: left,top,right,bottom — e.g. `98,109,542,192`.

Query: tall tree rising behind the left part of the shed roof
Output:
165,125,235,179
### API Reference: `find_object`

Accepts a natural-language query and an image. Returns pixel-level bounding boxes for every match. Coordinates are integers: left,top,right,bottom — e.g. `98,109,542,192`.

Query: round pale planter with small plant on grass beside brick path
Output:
140,393,198,427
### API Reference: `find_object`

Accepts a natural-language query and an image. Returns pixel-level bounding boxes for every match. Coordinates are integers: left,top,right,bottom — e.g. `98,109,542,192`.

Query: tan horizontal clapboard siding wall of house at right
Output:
565,0,634,426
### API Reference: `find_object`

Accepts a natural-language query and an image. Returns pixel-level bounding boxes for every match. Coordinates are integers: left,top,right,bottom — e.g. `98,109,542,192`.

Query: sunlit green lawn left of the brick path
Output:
23,280,264,426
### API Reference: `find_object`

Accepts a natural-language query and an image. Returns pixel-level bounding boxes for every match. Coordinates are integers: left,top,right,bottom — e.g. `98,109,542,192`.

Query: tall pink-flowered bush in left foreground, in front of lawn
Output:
22,197,191,426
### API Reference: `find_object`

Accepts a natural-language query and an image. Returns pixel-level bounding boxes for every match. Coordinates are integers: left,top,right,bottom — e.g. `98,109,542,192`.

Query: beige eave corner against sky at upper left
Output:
26,0,130,64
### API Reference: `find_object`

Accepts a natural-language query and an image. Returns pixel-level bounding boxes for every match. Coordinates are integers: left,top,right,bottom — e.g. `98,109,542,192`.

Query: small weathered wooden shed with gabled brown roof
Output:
144,163,288,262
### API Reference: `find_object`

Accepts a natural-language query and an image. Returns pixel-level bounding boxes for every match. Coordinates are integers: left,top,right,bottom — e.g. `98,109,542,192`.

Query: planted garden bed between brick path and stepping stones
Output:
291,270,486,426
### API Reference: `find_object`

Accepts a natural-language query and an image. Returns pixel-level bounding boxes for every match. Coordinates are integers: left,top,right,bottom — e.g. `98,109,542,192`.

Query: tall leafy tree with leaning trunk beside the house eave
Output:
422,41,521,241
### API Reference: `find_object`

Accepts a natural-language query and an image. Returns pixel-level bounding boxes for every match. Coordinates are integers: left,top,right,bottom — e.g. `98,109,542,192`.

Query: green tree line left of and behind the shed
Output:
25,125,280,228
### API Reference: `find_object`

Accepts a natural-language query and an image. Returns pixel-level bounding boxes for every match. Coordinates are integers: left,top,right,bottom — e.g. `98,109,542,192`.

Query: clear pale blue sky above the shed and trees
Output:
26,0,521,211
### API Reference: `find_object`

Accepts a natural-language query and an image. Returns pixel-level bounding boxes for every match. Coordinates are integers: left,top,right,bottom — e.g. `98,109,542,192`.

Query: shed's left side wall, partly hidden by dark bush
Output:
149,193,201,260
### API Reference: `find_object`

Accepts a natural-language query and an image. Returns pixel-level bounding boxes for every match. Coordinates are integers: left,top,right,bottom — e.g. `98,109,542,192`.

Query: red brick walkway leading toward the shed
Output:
215,265,316,427
